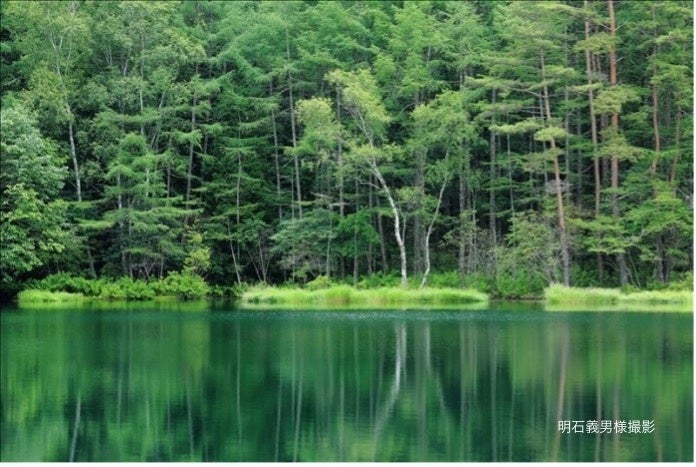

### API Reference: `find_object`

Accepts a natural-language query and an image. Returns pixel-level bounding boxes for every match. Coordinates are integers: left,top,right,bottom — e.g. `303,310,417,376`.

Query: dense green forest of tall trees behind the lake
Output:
0,0,694,297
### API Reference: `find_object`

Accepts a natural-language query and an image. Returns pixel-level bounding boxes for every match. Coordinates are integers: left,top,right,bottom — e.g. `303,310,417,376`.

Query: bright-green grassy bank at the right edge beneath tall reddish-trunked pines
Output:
544,284,693,312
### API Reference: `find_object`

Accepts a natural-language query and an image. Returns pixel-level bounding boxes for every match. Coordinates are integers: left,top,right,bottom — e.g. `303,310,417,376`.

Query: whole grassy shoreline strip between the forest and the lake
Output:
12,285,694,313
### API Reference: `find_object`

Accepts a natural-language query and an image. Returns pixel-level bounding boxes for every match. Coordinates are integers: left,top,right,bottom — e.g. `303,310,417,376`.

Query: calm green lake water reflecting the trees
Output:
0,305,693,461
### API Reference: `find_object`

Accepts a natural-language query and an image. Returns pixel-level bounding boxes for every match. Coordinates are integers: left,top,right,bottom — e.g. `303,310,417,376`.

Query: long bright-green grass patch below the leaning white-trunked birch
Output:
240,285,488,309
